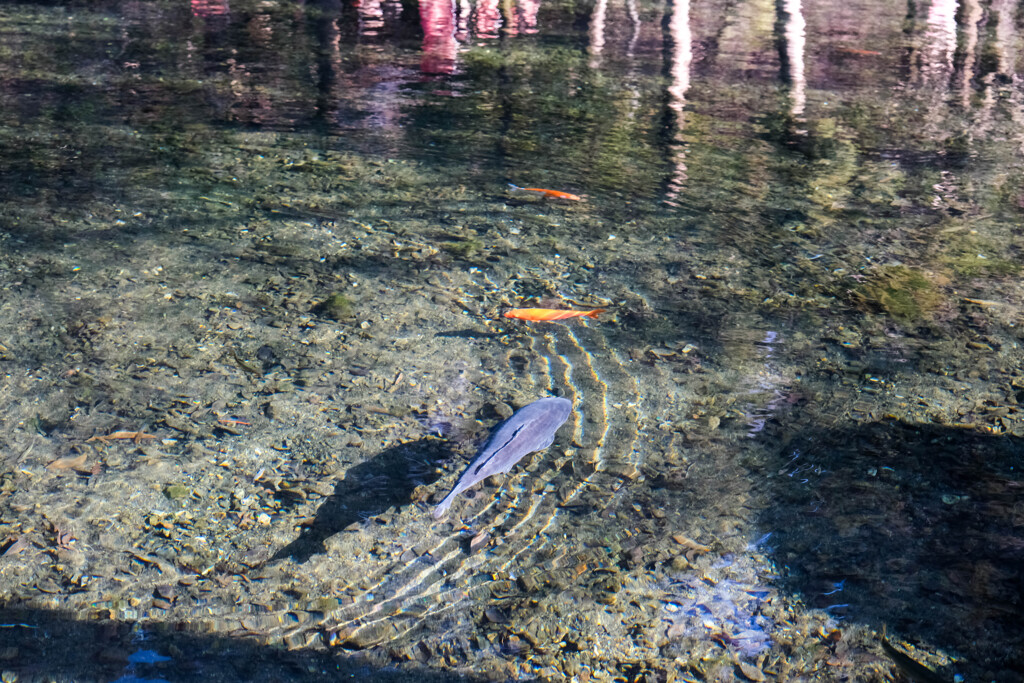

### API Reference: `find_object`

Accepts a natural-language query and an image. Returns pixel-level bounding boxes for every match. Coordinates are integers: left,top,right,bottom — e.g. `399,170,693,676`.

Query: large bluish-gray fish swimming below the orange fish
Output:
434,398,572,519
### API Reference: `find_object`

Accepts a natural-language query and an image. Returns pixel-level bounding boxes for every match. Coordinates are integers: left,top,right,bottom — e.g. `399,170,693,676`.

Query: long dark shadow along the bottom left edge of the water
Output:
0,608,485,683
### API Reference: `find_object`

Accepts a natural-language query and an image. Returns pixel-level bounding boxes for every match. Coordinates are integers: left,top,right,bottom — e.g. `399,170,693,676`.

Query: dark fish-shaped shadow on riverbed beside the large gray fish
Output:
270,437,452,562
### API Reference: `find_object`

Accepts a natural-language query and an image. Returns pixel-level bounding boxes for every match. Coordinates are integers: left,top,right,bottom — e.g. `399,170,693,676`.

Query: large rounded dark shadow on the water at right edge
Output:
761,421,1024,681
